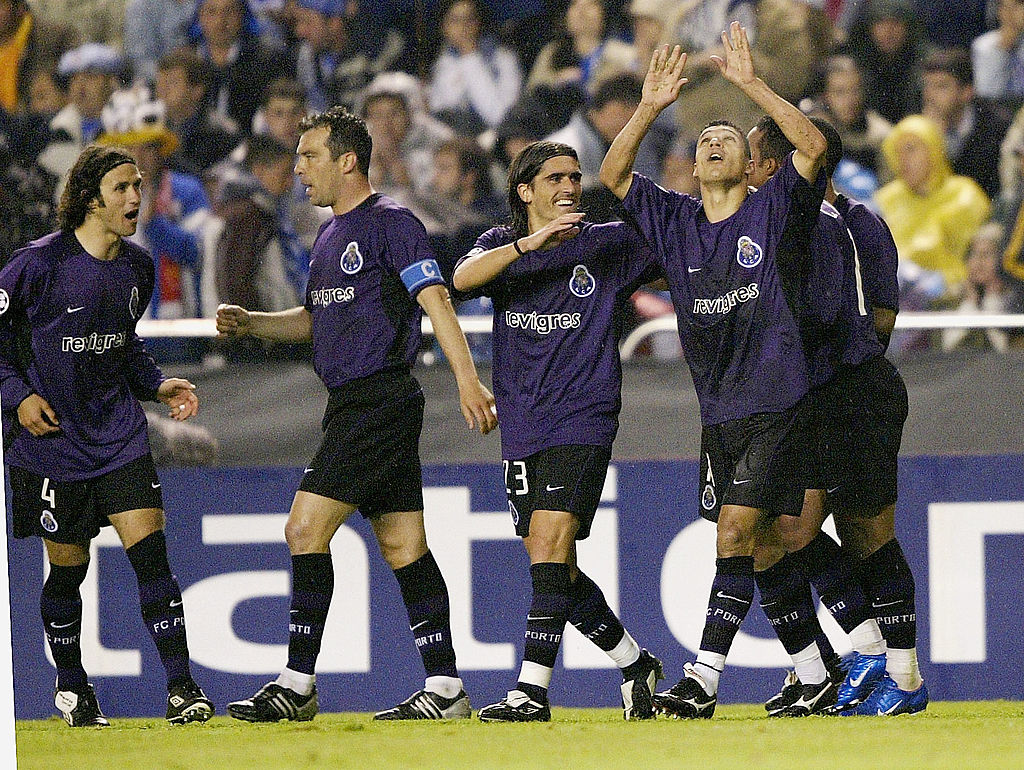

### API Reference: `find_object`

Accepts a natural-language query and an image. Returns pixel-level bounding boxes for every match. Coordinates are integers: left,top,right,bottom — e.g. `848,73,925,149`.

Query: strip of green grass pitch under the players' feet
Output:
15,701,1024,770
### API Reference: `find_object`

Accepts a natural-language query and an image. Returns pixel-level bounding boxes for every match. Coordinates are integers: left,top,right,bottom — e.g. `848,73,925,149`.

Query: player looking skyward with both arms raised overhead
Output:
601,23,825,718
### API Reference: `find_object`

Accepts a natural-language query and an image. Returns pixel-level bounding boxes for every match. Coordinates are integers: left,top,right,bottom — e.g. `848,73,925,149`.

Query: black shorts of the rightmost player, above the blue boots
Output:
811,355,907,515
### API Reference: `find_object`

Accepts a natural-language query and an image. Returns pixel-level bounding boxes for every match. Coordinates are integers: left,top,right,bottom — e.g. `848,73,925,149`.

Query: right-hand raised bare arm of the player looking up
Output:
712,22,827,182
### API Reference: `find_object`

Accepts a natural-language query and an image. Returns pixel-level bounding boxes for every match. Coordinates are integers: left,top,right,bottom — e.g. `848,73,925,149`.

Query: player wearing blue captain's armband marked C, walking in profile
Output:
217,108,497,722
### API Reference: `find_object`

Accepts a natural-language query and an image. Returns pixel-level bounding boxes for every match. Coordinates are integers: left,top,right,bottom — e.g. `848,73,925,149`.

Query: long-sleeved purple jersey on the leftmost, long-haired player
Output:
0,232,163,481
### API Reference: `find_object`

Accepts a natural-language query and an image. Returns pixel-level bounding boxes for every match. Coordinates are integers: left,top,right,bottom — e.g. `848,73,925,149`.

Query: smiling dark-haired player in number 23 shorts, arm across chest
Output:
453,141,663,722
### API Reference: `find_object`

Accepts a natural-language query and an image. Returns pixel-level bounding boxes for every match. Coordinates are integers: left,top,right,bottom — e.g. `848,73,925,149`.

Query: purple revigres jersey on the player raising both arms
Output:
623,155,824,425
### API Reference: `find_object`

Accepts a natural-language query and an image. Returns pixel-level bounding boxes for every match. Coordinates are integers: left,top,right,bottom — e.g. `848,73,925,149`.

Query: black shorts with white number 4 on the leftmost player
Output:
10,455,164,543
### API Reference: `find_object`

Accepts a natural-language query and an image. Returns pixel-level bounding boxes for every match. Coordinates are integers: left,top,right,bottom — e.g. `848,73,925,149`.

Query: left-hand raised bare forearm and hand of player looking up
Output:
599,45,687,201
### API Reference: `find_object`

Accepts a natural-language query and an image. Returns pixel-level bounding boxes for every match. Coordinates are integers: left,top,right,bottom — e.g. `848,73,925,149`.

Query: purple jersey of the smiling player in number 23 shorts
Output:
463,222,656,458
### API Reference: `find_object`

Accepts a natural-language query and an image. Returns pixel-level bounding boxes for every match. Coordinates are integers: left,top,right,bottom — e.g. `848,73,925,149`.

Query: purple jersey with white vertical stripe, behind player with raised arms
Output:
800,203,885,387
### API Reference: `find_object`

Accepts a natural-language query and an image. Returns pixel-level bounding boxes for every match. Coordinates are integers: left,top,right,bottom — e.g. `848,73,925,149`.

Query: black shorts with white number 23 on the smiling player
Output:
502,444,611,540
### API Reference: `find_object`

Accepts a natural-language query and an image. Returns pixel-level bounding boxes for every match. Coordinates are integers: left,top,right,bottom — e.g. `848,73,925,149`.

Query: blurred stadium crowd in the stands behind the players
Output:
0,0,1024,356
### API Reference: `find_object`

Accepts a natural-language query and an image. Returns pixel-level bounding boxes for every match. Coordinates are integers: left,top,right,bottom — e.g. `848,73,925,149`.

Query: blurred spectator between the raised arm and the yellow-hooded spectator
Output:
809,55,892,172
